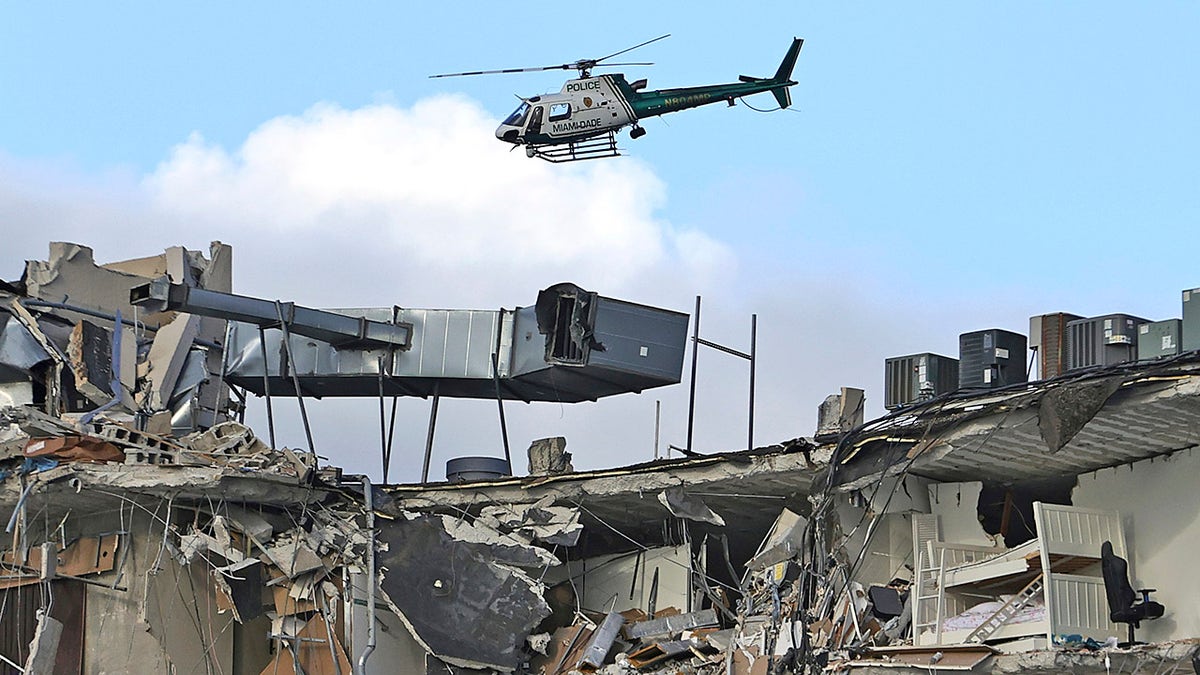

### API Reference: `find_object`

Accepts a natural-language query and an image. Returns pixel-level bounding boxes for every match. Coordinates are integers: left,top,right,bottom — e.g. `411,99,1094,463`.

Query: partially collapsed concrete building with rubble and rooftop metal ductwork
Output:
0,244,1200,675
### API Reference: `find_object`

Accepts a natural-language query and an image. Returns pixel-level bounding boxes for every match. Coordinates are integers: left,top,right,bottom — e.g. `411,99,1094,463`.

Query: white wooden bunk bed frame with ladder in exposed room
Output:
912,502,1128,645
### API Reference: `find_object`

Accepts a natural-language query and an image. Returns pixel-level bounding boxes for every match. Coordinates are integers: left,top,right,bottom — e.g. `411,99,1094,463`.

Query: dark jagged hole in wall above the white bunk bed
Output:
976,476,1075,548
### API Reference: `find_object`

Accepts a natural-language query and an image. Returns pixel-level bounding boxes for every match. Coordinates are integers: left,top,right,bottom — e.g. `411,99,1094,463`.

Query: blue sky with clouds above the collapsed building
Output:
0,1,1200,478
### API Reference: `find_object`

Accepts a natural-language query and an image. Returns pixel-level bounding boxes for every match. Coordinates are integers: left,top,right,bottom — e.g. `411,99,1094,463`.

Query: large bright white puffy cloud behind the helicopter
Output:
145,96,732,304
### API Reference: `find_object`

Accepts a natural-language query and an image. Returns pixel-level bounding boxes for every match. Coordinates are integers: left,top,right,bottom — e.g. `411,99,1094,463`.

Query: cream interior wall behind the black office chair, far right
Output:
1072,449,1200,641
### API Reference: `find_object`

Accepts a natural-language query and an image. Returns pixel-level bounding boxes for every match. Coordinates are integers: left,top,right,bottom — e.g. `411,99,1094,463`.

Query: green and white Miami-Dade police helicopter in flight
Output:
430,35,804,162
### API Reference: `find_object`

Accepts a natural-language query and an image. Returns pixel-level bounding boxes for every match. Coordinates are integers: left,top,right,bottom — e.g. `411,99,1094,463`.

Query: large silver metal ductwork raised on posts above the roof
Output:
133,283,689,402
